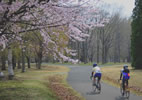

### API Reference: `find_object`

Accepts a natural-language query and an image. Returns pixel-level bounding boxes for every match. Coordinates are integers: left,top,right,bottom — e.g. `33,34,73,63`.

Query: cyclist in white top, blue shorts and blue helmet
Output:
91,63,102,86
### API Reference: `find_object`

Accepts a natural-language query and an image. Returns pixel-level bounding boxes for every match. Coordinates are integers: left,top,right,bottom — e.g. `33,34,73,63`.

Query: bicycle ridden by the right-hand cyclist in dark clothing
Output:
119,80,130,99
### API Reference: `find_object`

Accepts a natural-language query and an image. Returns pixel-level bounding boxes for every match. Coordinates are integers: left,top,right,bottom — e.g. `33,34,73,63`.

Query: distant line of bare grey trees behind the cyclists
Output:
70,11,131,64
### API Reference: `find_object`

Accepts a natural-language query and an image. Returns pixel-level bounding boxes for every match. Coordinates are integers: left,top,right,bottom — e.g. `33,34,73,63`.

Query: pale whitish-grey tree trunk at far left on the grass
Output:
8,47,14,80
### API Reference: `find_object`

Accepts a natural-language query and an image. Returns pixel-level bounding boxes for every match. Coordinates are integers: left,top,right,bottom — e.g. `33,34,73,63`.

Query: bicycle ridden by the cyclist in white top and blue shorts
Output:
92,77,101,94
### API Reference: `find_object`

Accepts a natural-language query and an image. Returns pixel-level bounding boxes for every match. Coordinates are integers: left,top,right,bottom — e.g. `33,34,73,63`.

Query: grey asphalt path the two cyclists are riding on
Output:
67,66,142,100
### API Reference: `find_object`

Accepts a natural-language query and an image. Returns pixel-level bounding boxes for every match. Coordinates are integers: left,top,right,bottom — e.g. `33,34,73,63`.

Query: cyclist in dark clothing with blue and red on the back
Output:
120,65,130,95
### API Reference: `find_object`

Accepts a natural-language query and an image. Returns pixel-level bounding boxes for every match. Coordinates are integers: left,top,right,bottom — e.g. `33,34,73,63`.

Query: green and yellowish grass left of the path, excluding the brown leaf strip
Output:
0,66,68,100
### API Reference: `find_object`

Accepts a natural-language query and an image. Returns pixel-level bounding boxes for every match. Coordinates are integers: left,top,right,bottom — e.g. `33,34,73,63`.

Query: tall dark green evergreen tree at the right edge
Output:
131,0,142,69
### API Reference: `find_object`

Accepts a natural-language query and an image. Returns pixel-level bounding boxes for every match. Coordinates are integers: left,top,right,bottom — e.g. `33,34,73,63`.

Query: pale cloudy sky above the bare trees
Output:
67,0,135,17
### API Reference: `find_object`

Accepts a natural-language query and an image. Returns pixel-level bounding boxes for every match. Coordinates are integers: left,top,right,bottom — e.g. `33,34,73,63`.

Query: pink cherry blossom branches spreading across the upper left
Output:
0,0,107,78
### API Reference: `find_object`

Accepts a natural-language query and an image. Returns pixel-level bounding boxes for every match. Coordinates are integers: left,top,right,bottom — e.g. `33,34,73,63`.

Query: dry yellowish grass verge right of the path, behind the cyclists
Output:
102,65,142,95
